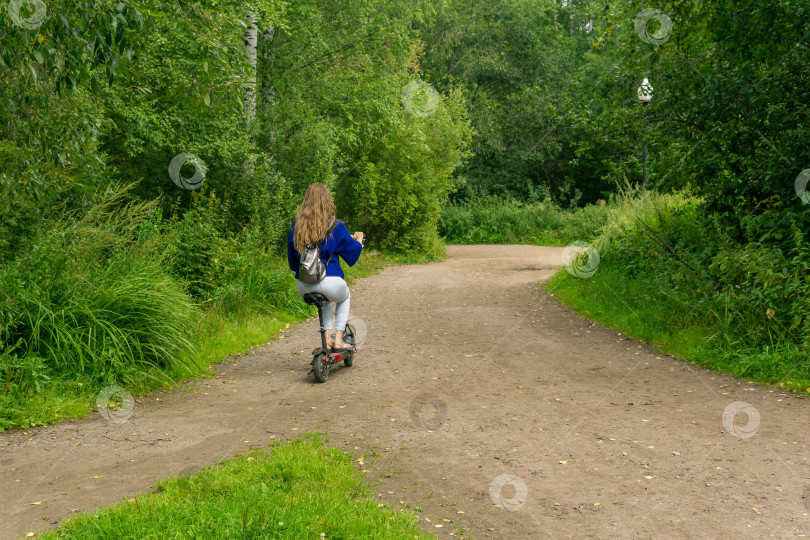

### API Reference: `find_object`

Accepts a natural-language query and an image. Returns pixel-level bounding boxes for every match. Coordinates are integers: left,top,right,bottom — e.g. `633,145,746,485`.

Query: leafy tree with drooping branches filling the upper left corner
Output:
0,0,149,255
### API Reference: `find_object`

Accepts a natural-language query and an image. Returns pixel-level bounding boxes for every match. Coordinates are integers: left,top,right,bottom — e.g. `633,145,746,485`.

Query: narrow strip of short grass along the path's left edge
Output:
0,249,414,431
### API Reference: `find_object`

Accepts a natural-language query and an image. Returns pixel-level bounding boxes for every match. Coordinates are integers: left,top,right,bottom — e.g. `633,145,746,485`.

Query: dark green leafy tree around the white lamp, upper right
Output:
564,0,810,225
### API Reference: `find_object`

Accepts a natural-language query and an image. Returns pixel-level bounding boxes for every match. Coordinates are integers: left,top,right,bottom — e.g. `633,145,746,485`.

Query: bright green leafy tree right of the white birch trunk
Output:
258,0,469,251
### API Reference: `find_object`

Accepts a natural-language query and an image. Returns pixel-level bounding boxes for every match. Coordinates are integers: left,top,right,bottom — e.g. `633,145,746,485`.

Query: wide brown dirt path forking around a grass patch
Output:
0,246,810,538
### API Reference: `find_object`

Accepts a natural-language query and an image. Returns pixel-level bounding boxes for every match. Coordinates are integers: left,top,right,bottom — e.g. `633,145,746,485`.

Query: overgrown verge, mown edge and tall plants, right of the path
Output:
545,186,810,393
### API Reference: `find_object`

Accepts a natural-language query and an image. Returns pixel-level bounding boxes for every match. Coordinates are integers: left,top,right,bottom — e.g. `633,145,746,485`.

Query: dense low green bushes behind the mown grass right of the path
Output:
596,201,810,347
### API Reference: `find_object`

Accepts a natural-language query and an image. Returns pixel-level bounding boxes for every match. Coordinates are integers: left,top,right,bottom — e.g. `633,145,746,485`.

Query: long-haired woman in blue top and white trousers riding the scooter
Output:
287,184,365,349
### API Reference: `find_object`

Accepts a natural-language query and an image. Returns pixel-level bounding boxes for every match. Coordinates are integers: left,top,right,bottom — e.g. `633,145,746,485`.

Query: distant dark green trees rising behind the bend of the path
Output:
421,0,606,202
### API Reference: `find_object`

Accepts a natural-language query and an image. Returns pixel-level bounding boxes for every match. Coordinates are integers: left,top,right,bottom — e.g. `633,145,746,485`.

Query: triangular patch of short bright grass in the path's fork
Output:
36,435,435,540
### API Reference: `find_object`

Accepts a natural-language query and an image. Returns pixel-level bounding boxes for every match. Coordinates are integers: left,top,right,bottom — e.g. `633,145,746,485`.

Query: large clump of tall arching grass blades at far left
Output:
0,189,200,428
